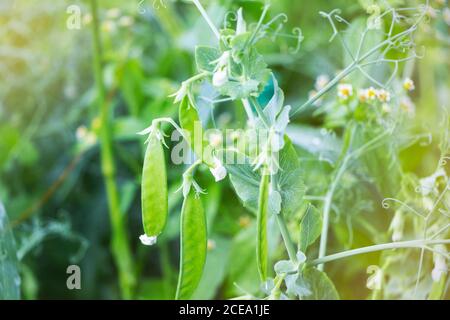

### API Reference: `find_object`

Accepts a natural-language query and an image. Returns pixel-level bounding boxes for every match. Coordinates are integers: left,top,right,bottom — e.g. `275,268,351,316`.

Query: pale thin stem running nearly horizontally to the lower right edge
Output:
310,240,450,266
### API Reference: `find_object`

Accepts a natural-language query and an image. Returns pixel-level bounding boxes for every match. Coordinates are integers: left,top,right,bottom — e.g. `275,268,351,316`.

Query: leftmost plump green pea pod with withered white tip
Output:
142,130,168,237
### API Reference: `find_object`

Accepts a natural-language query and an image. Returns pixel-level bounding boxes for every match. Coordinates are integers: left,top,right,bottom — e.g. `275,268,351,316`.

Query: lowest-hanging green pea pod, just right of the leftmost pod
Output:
176,190,207,300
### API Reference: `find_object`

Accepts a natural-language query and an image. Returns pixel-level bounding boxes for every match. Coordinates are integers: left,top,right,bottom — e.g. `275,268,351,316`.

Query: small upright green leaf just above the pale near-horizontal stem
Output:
298,205,322,252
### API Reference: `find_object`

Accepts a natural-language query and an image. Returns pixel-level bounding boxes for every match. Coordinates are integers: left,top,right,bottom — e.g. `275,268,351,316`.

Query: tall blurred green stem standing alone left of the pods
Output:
90,0,136,299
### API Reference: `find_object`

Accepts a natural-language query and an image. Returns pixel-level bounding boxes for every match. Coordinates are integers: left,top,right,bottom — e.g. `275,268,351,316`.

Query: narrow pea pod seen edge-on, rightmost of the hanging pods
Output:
256,174,269,281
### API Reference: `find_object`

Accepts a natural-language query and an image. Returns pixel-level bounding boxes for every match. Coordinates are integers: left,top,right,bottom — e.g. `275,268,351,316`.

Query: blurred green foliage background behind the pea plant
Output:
0,0,450,299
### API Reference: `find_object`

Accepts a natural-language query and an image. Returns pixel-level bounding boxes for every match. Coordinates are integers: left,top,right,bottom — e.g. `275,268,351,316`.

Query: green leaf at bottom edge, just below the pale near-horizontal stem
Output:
303,267,339,300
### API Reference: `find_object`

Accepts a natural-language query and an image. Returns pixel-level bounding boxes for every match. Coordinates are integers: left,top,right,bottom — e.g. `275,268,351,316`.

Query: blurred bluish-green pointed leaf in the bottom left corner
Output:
0,202,20,300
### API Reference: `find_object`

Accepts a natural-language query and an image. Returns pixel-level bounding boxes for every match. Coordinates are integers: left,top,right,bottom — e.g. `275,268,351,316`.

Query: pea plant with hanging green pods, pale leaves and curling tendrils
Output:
140,0,450,299
